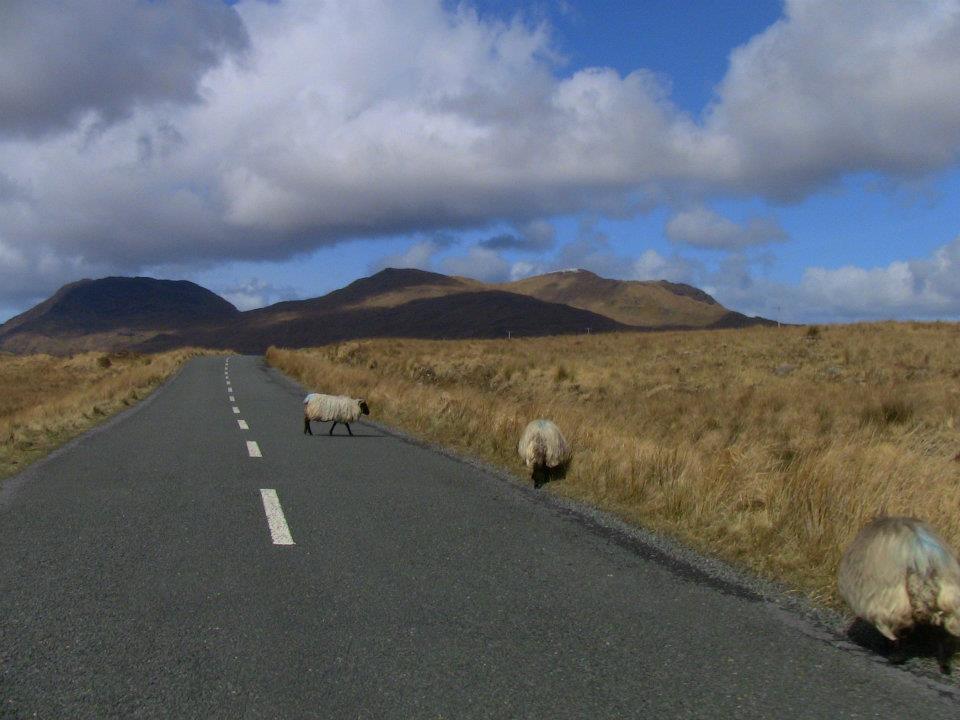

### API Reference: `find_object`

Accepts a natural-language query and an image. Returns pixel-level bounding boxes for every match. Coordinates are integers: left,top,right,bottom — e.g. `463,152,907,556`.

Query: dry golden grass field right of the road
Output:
267,323,960,604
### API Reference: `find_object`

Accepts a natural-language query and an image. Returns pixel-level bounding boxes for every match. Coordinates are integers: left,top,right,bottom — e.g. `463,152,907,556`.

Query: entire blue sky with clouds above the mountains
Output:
0,0,960,322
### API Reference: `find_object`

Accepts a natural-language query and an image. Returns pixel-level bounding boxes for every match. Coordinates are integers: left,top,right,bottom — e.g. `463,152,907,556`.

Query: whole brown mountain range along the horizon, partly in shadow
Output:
0,268,770,353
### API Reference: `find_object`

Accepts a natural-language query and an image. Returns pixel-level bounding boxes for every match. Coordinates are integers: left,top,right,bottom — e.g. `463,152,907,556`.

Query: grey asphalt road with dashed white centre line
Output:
0,357,960,720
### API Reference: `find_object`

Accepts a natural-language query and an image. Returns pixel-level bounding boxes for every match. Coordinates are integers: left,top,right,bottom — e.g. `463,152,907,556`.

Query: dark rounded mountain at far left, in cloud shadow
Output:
0,277,240,353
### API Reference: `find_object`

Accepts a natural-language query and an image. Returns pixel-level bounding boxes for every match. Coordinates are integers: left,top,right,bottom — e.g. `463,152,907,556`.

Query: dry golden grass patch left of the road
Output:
0,349,212,478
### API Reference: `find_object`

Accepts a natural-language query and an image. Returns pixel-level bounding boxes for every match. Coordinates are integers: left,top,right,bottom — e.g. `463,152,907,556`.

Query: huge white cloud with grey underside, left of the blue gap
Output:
0,0,724,306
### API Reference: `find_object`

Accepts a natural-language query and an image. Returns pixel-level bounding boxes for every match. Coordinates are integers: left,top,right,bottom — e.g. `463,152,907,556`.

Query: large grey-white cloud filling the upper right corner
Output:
706,0,960,199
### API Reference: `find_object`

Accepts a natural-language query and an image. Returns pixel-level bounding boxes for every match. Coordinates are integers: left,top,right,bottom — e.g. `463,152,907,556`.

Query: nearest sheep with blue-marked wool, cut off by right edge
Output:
838,517,960,670
